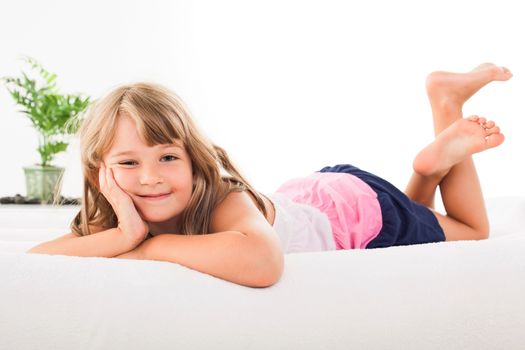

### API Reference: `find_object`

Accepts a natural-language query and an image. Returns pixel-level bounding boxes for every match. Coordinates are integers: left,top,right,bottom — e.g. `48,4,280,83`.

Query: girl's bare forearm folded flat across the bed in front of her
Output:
117,231,283,287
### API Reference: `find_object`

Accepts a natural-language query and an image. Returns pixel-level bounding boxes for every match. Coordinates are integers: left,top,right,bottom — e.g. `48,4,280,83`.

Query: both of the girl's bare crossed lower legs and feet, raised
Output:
406,64,511,240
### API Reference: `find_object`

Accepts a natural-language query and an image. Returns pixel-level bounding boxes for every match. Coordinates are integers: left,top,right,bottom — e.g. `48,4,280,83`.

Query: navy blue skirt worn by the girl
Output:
319,164,445,249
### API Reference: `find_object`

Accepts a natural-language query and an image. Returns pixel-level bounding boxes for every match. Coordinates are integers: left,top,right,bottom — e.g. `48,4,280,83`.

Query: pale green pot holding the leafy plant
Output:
23,165,65,204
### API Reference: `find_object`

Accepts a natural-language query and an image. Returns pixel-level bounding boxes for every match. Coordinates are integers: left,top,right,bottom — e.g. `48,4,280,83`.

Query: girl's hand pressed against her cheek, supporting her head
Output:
99,163,149,248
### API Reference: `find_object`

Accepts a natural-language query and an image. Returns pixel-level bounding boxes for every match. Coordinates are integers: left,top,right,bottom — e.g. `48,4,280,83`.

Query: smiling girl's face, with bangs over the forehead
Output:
103,116,193,234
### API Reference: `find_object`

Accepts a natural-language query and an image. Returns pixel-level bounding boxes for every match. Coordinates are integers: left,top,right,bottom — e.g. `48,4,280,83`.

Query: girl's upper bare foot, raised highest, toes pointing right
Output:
426,63,512,107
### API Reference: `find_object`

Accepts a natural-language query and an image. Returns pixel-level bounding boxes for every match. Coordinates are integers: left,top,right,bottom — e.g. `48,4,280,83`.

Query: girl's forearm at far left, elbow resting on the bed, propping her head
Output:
27,228,133,258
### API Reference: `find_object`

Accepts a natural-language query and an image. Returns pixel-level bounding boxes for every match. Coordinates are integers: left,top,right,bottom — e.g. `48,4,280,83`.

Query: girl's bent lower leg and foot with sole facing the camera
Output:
414,116,504,240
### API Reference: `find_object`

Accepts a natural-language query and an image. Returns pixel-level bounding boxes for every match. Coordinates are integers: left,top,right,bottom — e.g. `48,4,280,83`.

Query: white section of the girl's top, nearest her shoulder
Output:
267,193,336,254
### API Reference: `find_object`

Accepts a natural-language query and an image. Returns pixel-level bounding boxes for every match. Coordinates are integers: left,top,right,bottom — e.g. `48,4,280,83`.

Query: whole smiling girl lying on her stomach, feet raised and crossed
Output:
29,64,512,287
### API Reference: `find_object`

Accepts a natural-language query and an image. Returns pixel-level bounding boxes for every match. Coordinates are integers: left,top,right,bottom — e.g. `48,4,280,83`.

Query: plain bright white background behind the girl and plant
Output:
0,0,525,202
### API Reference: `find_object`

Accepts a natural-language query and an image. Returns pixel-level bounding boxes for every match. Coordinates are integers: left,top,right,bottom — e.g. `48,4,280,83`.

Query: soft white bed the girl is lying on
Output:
0,197,525,350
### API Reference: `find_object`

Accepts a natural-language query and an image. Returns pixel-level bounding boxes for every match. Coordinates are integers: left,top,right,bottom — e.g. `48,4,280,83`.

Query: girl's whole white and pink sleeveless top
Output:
268,172,382,253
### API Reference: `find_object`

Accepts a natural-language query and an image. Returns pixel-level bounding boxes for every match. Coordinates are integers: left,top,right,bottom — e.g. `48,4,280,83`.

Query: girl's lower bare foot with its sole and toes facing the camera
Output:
413,116,505,177
